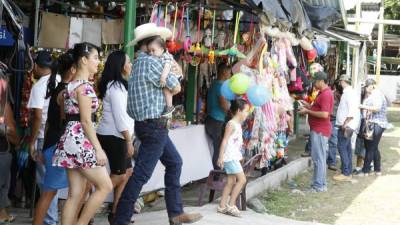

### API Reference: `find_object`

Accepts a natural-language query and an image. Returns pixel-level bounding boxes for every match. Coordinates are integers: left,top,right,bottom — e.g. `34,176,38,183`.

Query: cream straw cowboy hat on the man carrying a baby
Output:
127,23,172,47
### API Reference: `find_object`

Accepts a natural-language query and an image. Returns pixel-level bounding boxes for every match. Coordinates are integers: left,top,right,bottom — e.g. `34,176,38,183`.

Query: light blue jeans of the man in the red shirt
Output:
310,131,328,191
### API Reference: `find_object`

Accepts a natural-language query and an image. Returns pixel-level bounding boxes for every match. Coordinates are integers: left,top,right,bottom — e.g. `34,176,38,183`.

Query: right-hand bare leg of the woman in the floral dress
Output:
76,167,112,225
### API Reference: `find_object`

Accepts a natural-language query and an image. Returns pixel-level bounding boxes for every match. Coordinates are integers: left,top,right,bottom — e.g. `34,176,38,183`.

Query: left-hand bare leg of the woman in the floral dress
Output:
61,169,87,225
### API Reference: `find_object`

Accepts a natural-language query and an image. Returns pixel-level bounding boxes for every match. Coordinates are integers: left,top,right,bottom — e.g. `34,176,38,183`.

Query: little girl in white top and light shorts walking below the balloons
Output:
217,99,250,217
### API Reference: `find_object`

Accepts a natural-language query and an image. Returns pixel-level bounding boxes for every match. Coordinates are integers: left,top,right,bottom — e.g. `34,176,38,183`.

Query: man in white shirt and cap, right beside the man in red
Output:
333,75,360,181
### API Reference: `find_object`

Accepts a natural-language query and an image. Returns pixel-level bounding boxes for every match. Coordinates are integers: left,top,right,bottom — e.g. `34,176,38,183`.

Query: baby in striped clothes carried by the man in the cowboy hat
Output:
148,37,182,117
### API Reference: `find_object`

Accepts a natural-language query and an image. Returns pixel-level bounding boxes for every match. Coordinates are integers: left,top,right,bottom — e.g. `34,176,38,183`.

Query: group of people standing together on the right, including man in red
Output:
298,72,389,192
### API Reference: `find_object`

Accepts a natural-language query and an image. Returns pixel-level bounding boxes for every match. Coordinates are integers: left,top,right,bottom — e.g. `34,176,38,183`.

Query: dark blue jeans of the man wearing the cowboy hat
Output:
114,121,183,225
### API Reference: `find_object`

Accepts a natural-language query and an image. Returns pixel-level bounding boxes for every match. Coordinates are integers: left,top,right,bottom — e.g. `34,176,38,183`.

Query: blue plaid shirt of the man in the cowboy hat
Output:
127,52,179,121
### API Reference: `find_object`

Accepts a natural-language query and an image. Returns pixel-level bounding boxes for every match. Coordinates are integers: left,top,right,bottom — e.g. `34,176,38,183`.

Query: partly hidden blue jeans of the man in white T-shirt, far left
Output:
36,138,58,225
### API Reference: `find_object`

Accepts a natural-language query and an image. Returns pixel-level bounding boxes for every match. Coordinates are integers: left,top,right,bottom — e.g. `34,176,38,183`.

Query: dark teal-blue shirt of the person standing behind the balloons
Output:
207,80,226,122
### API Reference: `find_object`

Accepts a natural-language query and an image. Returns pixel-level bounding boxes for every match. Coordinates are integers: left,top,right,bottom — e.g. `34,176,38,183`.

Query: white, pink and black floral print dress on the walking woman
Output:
53,80,99,169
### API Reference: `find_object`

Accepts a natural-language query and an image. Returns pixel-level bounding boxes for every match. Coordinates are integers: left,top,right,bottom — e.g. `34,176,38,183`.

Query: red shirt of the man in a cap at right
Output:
308,87,333,138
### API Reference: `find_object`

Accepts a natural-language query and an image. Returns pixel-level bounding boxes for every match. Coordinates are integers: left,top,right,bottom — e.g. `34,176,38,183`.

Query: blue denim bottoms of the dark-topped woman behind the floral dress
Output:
43,145,68,191
